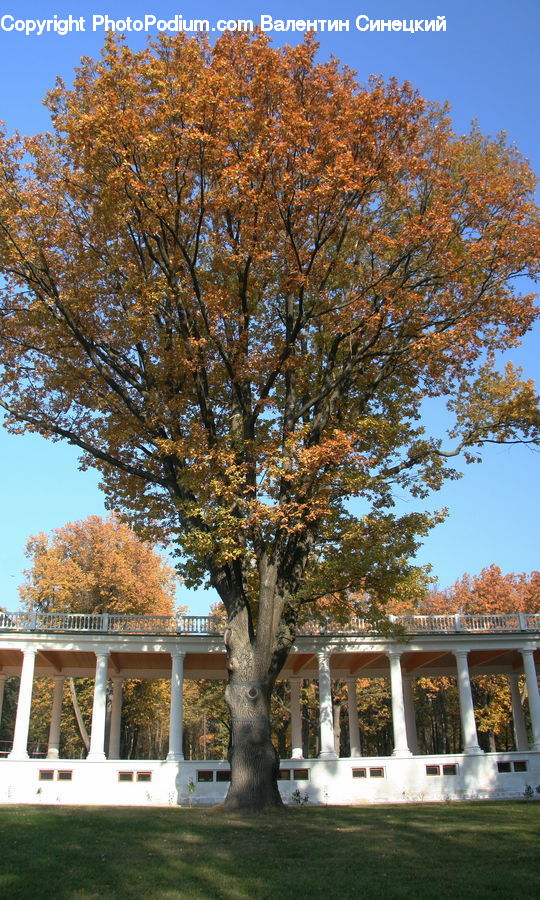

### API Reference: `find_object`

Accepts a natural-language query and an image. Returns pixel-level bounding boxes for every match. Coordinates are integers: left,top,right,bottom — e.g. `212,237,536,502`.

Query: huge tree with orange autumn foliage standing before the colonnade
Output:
0,34,539,809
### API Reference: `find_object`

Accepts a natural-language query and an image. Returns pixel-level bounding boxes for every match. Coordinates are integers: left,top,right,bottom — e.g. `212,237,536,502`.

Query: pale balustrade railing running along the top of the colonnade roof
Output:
0,610,540,635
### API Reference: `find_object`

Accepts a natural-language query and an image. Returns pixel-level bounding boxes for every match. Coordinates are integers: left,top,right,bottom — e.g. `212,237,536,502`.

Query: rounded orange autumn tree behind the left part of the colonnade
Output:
18,516,177,759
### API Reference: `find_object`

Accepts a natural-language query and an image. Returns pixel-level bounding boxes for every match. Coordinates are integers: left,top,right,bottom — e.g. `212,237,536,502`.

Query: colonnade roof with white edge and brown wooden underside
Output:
0,616,540,680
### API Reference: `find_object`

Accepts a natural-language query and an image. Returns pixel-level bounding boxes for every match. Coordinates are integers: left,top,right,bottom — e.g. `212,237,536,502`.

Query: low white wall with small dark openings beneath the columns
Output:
0,751,540,806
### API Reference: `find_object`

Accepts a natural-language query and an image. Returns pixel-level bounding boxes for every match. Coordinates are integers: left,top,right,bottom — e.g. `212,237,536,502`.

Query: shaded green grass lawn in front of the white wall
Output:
0,801,540,900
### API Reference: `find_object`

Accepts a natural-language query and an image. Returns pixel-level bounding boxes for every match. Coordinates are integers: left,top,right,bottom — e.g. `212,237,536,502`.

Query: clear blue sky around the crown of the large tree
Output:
0,0,540,614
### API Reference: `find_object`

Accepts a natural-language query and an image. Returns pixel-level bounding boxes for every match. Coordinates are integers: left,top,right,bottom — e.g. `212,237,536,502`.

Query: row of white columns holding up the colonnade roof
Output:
0,644,540,762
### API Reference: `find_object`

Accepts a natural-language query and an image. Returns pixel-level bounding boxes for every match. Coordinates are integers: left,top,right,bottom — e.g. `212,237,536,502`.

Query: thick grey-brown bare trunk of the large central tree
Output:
224,629,284,812
